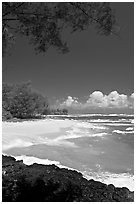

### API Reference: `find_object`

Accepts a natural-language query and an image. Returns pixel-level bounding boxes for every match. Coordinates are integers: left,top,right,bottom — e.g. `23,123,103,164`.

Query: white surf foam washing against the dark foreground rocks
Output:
15,155,134,191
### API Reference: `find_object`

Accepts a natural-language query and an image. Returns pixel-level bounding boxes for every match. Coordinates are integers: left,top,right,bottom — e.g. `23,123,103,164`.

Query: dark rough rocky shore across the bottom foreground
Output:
2,156,134,202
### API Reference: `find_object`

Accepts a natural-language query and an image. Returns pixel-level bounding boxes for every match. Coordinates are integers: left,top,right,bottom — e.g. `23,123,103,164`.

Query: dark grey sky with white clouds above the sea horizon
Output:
3,2,134,113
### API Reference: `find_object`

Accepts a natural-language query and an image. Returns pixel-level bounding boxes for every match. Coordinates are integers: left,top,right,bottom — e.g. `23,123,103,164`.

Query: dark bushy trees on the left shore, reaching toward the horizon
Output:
2,82,68,120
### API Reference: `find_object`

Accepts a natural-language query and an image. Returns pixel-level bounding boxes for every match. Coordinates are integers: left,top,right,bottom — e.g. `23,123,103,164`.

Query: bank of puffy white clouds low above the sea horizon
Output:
60,91,134,109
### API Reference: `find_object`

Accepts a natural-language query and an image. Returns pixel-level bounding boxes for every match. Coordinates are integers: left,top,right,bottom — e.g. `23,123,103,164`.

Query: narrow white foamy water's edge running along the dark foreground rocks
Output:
2,153,134,192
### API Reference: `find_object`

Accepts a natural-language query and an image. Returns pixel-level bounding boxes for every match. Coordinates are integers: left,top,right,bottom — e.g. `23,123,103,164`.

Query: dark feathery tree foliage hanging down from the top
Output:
2,2,116,54
